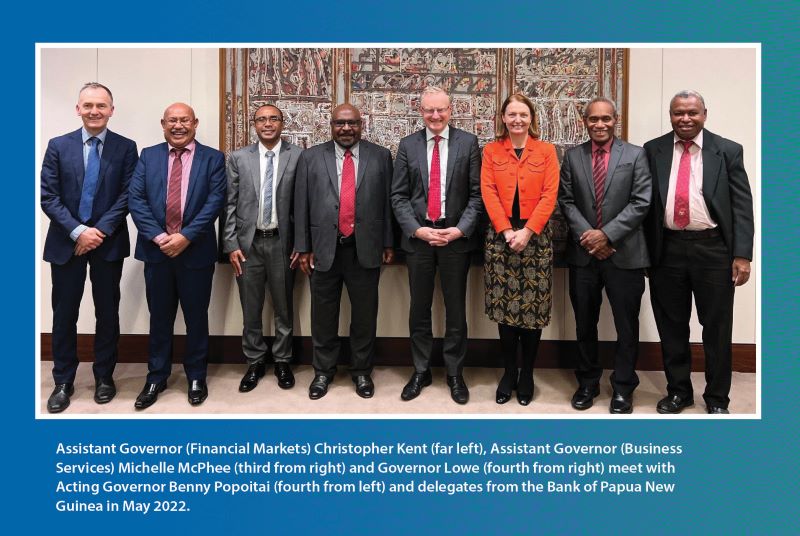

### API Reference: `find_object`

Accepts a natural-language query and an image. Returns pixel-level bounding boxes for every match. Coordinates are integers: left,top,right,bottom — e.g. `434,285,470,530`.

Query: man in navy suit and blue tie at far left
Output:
41,82,137,413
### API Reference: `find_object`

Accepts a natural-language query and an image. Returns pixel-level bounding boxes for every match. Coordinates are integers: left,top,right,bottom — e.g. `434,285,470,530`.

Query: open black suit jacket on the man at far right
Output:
644,129,754,266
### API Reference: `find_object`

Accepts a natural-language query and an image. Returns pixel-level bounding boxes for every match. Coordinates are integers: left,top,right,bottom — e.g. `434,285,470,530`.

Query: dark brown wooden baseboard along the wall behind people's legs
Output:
41,333,756,372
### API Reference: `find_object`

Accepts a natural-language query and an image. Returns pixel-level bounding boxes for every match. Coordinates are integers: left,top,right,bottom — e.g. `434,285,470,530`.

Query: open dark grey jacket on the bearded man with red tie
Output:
294,140,394,272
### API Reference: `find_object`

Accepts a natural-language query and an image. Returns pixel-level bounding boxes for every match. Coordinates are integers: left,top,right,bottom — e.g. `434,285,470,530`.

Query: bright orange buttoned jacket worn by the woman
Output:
481,136,558,234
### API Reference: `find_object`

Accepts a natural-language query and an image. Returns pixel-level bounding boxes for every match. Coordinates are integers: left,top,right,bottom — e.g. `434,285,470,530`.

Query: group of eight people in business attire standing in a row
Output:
41,83,754,413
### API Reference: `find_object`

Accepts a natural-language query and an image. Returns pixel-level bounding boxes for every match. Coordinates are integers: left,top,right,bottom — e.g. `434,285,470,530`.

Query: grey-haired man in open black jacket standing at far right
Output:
644,91,754,414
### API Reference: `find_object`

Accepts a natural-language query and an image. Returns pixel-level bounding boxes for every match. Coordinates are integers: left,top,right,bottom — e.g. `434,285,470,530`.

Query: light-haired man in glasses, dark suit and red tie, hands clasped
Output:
392,87,483,404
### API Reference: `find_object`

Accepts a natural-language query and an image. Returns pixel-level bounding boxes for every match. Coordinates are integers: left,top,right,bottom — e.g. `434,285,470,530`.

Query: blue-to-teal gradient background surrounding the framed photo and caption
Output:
7,1,800,534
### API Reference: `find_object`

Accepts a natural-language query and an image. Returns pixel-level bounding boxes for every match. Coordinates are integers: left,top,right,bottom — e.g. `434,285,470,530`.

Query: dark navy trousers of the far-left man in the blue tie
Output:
50,251,122,384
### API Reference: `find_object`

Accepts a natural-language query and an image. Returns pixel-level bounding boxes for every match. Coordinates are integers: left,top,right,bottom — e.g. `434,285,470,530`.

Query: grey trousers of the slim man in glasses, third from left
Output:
236,235,294,365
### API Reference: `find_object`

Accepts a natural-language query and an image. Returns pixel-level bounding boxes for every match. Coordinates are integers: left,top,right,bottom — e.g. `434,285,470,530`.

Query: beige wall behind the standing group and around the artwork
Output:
35,48,760,343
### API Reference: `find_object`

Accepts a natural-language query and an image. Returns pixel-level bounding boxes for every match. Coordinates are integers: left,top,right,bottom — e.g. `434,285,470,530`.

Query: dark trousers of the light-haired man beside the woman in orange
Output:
406,240,469,376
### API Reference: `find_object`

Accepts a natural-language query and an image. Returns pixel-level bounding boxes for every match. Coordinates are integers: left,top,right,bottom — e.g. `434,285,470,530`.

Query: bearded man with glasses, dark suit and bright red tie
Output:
294,104,394,400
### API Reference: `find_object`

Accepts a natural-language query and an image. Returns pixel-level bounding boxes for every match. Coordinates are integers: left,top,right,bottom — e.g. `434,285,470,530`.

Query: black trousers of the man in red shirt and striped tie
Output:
569,259,644,396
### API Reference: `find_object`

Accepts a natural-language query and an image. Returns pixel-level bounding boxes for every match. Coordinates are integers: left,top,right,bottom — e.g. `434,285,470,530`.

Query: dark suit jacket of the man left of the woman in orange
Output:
392,126,483,253
